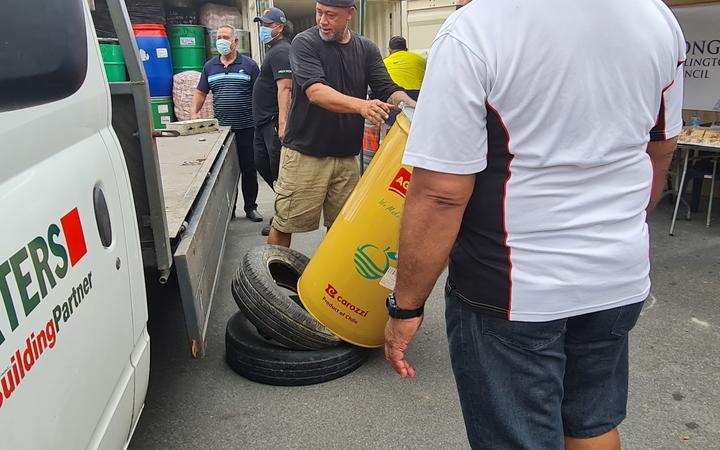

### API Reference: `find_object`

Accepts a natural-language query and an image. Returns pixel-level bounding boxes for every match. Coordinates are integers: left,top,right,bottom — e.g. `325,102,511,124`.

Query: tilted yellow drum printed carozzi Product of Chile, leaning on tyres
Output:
298,109,412,347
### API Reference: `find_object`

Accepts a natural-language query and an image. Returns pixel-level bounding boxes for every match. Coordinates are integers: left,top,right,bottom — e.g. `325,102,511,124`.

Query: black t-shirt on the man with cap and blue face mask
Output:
253,39,292,126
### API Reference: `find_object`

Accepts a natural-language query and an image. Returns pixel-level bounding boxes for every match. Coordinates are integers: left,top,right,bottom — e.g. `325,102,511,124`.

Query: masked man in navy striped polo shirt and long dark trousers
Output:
191,25,263,222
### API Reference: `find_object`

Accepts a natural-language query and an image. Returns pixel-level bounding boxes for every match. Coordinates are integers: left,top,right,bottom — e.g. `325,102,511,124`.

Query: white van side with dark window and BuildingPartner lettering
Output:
0,0,142,448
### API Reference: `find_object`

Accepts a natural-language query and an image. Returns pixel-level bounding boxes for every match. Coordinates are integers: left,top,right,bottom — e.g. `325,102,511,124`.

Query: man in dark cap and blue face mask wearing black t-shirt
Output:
253,8,292,236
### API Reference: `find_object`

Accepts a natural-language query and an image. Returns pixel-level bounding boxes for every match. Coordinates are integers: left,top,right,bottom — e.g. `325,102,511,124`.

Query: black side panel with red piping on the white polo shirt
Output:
449,102,513,318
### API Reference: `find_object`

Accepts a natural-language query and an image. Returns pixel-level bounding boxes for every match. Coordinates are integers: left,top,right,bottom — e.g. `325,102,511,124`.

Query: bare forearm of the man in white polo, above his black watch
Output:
395,169,475,309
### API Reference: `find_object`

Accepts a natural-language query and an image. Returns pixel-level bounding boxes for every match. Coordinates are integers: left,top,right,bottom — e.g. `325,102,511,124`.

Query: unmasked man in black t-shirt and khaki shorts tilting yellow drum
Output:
268,0,415,247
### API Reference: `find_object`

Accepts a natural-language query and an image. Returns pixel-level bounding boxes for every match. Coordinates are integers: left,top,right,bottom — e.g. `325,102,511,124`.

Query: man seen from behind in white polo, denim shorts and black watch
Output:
385,0,685,449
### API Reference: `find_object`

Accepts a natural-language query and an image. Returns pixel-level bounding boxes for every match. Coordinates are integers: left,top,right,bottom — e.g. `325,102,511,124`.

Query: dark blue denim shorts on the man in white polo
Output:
445,288,643,450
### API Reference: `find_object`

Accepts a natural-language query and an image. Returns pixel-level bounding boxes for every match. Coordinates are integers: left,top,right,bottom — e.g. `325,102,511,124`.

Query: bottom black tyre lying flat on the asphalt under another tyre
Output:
225,312,370,386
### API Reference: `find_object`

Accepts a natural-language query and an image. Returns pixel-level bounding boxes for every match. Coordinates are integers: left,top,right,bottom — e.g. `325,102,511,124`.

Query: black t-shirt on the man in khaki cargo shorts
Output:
284,27,402,156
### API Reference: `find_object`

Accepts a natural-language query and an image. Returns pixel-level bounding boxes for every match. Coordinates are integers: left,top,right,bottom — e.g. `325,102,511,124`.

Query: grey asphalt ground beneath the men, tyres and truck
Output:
130,186,720,450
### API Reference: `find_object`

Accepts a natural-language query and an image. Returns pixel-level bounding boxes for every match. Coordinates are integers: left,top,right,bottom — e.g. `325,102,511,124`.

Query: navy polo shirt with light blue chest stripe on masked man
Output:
197,53,260,130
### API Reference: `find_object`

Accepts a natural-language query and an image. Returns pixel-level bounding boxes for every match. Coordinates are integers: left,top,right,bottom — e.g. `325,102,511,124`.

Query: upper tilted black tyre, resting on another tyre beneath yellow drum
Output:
232,245,341,350
